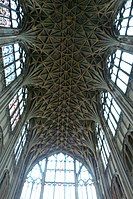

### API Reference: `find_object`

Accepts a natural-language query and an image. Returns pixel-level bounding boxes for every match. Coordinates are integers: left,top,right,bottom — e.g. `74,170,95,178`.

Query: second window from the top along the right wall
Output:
107,50,133,93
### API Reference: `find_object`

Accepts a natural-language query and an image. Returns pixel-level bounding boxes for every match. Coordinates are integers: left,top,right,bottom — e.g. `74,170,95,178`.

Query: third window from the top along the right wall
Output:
101,92,121,135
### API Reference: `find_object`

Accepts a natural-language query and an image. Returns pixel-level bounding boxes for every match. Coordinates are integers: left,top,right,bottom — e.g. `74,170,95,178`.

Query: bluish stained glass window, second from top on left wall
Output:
2,43,26,85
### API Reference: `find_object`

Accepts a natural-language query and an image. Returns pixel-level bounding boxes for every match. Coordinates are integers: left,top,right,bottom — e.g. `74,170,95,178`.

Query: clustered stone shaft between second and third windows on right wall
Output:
109,80,133,124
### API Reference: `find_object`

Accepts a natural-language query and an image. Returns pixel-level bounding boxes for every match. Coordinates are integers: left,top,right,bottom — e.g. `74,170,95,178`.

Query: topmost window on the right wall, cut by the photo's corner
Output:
115,0,133,35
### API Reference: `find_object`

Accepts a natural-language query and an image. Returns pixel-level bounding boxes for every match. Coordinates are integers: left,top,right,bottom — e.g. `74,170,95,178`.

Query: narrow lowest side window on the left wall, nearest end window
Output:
14,123,29,164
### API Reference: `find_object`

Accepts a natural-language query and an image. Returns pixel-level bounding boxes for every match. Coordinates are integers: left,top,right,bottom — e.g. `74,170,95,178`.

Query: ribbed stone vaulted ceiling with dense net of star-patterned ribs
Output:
21,0,119,165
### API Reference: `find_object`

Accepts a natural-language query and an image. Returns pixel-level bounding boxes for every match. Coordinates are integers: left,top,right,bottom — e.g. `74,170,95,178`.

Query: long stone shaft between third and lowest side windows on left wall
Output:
0,110,26,177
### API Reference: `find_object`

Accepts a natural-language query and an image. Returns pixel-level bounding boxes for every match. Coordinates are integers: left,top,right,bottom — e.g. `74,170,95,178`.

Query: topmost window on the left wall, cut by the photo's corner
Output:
0,0,24,28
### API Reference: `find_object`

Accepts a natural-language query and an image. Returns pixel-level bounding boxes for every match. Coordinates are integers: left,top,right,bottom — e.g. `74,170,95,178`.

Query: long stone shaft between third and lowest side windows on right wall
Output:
100,116,133,198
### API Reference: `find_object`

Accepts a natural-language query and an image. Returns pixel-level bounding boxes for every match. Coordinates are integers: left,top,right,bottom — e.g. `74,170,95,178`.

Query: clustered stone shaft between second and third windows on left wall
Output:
0,74,23,114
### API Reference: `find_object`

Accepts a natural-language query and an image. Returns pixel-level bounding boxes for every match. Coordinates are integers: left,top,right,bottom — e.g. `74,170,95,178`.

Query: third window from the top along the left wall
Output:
9,88,27,130
